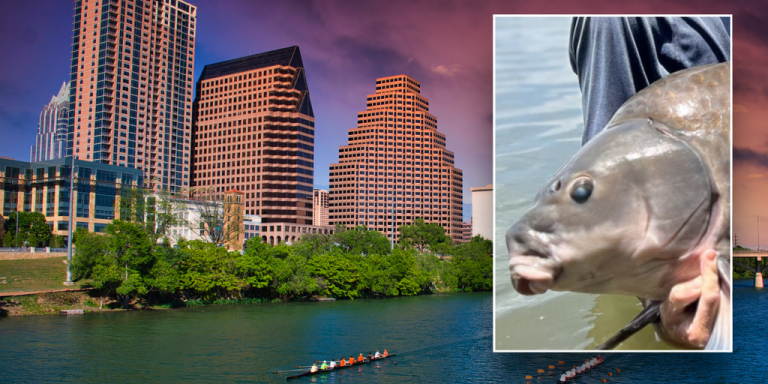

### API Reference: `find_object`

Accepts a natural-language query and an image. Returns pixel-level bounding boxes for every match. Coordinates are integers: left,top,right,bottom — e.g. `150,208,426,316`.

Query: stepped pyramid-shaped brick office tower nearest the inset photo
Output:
329,75,464,242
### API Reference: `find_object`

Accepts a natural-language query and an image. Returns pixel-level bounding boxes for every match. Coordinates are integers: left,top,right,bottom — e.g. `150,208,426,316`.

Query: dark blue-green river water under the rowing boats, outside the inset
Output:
0,280,768,384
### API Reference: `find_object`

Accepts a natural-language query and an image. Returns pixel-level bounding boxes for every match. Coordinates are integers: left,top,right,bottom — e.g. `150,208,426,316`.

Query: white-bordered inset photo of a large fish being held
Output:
493,15,733,352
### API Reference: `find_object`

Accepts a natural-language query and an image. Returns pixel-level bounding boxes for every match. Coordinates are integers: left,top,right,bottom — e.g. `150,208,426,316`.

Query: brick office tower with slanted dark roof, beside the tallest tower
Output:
192,46,315,228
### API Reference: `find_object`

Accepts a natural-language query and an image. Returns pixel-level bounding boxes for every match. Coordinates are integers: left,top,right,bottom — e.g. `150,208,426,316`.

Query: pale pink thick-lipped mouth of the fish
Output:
509,250,561,296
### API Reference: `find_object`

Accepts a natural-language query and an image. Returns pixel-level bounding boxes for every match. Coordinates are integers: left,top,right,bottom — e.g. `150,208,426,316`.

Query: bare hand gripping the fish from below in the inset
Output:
654,249,720,349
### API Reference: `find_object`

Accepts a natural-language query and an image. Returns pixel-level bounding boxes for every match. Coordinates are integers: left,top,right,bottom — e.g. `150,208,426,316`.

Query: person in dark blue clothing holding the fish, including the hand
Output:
570,17,731,349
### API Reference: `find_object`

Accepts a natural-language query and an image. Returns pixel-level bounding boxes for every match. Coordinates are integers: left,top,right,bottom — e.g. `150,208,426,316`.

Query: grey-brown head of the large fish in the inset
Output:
506,119,715,299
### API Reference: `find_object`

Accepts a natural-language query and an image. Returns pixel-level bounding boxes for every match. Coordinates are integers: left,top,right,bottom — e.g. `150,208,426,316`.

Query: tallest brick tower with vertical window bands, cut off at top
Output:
67,0,197,192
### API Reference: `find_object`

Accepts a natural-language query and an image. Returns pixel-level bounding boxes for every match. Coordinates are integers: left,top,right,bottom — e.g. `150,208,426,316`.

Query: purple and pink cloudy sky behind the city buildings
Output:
0,0,768,224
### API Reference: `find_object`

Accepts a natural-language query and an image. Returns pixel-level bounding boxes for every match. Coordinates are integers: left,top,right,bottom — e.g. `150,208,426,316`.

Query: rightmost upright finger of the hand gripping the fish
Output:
689,250,720,347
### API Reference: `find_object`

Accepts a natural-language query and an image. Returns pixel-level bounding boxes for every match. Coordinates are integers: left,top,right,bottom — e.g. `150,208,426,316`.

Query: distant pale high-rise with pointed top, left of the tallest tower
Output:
29,82,69,162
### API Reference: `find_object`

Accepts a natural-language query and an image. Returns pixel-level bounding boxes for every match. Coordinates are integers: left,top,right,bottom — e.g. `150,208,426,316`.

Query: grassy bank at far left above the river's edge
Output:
0,257,90,292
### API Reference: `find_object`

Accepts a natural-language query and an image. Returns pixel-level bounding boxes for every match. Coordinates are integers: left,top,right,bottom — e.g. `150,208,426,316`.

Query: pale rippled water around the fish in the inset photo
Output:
494,17,668,350
